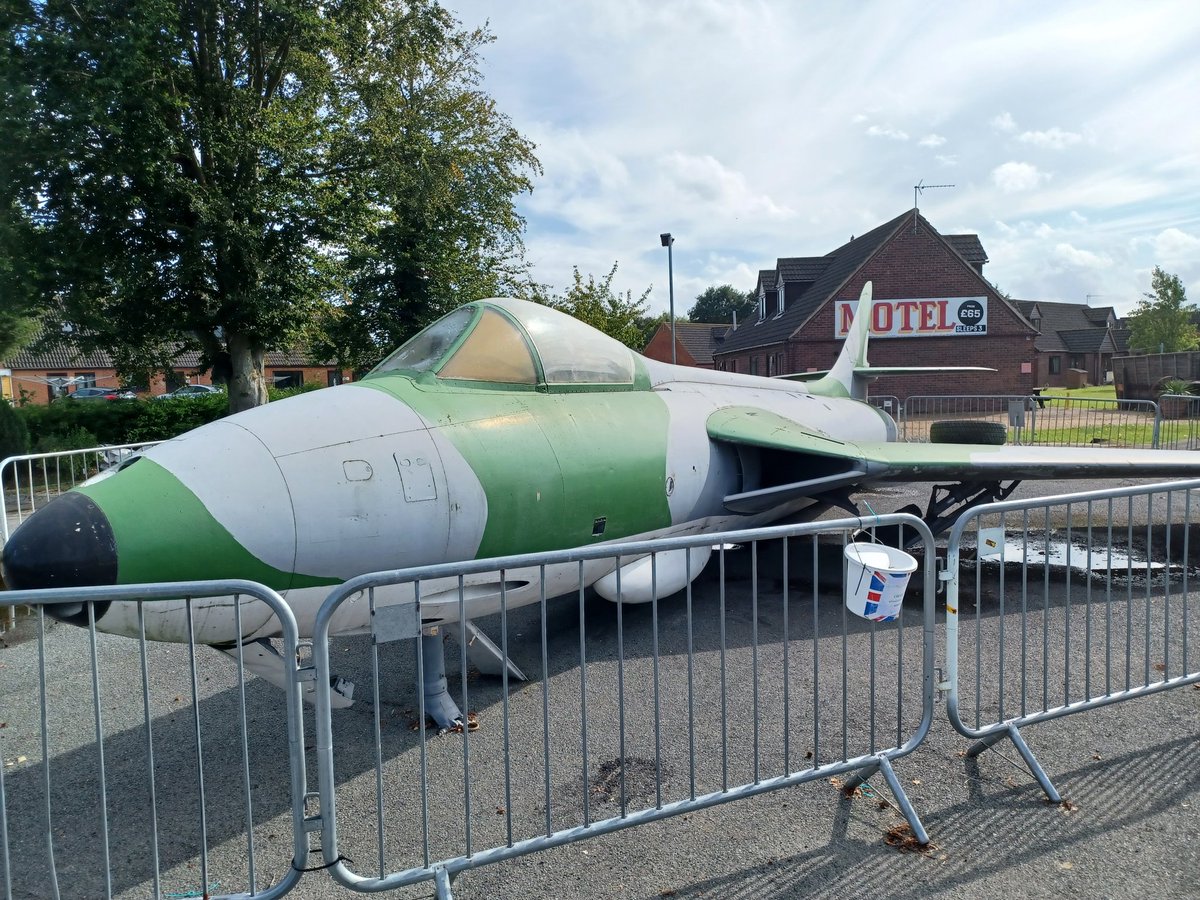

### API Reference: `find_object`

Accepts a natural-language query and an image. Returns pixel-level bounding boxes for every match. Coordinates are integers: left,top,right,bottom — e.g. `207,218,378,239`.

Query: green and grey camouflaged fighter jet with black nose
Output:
4,283,1200,715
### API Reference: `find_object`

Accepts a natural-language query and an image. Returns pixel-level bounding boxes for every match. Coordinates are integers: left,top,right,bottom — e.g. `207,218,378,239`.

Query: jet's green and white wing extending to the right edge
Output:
708,407,1200,512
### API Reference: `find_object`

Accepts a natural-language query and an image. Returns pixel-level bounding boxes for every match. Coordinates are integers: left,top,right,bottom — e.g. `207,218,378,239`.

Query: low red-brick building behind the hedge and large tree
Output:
0,336,350,403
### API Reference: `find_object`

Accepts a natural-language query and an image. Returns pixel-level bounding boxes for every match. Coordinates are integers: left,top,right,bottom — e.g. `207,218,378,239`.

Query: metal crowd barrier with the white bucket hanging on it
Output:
313,515,935,898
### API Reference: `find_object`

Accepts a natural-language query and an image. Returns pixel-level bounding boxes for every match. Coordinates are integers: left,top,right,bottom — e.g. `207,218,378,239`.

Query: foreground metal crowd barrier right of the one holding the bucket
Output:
942,480,1200,802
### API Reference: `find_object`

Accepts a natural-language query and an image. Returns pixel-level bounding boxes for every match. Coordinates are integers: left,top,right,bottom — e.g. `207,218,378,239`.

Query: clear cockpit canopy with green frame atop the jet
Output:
367,299,637,385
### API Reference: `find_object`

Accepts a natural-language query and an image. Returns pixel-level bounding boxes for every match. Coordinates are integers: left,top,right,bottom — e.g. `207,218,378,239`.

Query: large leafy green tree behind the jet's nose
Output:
0,0,536,410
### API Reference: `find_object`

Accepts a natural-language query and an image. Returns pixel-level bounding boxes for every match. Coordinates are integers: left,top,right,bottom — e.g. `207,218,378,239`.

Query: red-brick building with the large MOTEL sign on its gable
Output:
713,209,1046,400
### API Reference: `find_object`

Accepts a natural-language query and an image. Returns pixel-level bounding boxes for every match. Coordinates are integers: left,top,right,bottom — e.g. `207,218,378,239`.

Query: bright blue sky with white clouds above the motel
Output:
443,0,1200,312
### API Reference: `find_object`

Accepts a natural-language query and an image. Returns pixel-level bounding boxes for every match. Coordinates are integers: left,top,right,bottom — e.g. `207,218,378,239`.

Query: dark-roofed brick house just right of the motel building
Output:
1015,300,1128,388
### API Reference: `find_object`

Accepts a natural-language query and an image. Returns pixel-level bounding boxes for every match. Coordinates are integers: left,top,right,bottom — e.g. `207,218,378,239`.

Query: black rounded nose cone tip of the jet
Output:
4,492,116,595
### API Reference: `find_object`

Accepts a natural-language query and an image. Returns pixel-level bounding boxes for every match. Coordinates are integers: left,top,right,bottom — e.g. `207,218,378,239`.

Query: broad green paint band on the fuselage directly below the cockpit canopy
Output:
356,374,671,558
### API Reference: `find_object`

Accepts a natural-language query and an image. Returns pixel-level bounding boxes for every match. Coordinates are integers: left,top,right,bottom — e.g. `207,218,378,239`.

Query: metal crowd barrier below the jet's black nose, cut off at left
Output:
0,581,307,900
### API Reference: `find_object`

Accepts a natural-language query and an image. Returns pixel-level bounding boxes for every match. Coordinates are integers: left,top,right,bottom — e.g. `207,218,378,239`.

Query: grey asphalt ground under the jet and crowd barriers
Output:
0,475,1200,898
